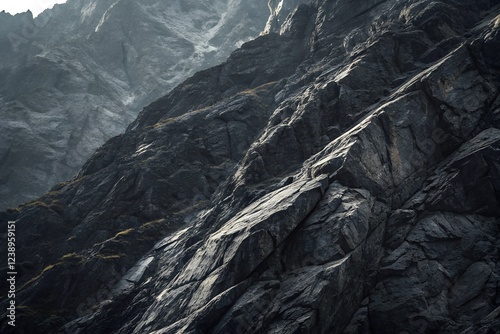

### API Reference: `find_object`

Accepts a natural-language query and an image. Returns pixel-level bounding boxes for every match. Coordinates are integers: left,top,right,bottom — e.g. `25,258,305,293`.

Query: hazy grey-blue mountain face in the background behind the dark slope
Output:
0,0,269,209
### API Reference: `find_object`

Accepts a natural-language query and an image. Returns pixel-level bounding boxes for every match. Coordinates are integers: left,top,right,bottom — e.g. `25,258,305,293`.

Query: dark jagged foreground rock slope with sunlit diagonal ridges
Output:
1,0,500,334
